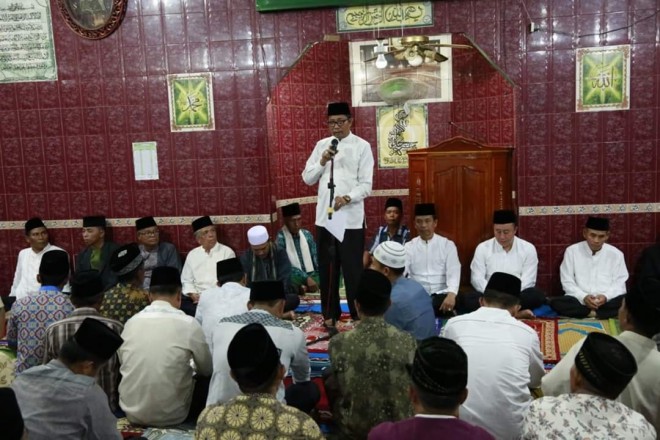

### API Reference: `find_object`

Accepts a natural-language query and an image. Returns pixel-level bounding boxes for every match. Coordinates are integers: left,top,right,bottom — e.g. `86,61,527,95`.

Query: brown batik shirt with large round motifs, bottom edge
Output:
195,394,323,440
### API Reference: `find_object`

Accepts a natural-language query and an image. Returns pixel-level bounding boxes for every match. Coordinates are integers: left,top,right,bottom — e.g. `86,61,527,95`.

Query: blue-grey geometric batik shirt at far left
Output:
7,286,73,374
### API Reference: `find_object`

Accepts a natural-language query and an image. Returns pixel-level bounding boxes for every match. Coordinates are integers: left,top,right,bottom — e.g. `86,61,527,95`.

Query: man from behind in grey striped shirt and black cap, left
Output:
43,270,124,412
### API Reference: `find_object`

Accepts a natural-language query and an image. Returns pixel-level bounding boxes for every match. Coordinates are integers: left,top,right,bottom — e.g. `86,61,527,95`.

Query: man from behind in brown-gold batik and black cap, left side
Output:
99,243,149,324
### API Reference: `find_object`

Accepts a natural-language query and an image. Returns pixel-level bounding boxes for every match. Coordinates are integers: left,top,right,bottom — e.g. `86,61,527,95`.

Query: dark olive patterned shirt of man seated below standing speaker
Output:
328,317,416,438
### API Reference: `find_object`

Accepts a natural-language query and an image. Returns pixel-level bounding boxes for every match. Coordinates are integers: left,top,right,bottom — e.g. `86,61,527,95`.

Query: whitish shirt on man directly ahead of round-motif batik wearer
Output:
206,309,310,406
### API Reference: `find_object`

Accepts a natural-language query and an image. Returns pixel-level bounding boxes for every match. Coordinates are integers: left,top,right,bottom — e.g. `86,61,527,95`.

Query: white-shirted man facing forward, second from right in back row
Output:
470,210,545,318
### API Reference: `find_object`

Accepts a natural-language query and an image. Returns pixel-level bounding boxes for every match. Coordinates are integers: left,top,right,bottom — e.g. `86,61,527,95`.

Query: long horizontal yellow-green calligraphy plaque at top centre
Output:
337,2,433,32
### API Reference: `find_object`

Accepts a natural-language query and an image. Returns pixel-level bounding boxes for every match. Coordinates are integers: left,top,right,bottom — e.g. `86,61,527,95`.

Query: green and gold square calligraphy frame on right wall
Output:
575,45,630,112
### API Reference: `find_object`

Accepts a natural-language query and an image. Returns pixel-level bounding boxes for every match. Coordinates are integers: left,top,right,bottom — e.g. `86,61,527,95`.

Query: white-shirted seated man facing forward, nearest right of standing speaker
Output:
405,203,463,316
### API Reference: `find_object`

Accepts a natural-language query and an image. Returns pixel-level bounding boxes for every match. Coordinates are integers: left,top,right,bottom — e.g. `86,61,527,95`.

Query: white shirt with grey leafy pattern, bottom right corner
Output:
520,394,656,440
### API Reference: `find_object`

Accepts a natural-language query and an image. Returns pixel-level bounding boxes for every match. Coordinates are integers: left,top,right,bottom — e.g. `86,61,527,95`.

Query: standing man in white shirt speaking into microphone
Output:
302,102,374,326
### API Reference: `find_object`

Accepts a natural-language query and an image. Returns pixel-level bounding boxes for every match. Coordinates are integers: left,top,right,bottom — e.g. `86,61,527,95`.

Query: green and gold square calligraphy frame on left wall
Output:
167,73,215,132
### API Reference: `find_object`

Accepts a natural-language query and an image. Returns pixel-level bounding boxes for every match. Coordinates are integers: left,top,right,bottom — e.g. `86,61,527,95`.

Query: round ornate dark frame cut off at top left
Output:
56,0,128,40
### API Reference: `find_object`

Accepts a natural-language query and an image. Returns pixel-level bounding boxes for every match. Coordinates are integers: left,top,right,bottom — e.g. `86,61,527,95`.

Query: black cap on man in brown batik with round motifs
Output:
227,322,280,388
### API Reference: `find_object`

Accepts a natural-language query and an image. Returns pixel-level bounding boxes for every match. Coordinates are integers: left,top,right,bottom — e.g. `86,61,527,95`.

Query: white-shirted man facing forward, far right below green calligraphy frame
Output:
550,217,628,319
